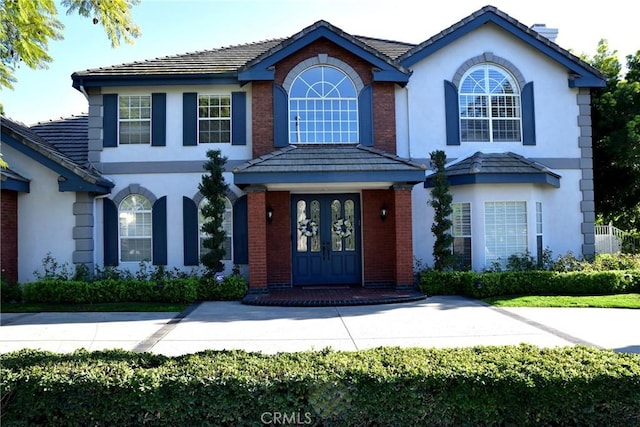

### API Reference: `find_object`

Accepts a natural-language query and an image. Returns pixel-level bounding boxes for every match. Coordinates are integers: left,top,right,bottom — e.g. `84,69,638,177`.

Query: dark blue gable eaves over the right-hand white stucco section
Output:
398,6,605,87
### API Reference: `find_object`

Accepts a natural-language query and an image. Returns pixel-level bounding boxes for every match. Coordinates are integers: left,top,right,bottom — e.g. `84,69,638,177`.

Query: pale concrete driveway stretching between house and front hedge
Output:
0,297,640,356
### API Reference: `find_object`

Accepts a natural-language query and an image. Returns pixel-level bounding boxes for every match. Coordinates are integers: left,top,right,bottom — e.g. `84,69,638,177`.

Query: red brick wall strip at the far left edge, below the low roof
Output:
0,190,18,283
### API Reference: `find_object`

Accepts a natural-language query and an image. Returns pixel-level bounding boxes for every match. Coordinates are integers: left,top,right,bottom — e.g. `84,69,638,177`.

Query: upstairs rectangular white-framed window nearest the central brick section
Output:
198,95,231,144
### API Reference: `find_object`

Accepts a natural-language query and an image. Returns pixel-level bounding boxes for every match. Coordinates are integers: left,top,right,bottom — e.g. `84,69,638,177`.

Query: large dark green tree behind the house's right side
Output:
590,40,640,231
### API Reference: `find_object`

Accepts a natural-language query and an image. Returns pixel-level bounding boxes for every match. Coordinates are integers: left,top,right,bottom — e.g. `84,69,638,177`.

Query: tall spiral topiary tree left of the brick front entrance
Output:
198,150,229,275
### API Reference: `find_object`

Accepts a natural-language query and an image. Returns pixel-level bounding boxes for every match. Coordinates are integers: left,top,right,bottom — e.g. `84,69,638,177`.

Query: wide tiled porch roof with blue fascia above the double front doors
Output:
233,144,426,187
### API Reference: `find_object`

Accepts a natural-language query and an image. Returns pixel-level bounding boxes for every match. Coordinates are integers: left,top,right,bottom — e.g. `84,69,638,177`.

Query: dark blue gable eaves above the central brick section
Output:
238,21,410,84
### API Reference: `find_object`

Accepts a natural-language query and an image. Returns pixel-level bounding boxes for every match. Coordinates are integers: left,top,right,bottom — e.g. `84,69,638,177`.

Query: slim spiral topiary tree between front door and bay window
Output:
429,150,453,270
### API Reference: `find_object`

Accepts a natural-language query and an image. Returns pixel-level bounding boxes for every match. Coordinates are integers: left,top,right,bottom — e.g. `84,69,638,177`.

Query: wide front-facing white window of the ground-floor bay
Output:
484,201,529,267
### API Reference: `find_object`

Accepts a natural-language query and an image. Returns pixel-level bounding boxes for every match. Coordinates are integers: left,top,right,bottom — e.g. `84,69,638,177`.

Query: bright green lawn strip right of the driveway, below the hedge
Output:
483,294,640,309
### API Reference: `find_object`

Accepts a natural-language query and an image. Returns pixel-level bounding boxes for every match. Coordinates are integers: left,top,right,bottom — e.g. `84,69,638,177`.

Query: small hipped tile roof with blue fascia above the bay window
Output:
425,151,561,188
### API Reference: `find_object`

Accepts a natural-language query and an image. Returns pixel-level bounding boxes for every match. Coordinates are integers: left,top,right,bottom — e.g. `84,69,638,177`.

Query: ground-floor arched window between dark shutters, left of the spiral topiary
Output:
118,194,153,262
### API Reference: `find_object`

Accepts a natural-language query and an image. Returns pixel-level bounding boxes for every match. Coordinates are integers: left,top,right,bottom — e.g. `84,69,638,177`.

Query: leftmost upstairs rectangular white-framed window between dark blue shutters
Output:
118,95,151,144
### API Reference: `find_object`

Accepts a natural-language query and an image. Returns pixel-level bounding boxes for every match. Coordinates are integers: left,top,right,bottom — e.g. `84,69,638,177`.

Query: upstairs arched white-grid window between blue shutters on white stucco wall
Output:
458,64,522,142
